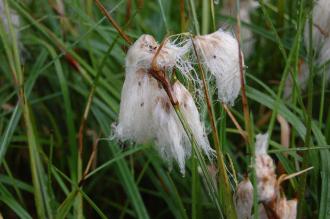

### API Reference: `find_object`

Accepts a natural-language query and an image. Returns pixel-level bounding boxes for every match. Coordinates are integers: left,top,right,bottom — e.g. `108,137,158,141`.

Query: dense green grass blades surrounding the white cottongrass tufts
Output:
0,0,330,218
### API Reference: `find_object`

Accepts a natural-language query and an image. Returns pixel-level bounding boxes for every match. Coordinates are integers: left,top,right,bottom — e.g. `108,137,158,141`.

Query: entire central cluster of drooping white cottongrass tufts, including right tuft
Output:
115,29,240,173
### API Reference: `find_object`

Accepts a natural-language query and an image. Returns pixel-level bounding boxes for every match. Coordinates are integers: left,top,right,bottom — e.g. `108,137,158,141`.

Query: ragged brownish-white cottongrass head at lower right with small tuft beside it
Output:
235,134,297,219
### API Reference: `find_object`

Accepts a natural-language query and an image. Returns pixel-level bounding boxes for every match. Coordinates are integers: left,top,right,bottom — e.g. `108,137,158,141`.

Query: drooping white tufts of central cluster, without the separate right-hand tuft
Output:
115,35,213,173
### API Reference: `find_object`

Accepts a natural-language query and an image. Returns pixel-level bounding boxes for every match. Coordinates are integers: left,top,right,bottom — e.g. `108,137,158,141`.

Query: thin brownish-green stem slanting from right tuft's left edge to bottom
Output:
191,39,236,218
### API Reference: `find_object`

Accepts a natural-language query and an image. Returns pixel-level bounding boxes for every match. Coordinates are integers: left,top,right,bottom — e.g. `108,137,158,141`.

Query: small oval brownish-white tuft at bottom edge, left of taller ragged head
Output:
234,178,253,219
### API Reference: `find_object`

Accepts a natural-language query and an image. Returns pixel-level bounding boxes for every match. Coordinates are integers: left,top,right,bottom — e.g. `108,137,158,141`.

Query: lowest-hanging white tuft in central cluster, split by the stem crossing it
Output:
153,81,214,173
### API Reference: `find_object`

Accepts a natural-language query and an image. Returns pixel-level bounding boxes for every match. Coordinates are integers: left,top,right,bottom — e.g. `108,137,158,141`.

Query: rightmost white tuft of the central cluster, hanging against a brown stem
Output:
194,29,241,105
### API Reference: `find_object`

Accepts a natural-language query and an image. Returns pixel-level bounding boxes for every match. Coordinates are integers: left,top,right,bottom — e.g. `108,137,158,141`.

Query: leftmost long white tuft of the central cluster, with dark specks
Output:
115,35,164,143
